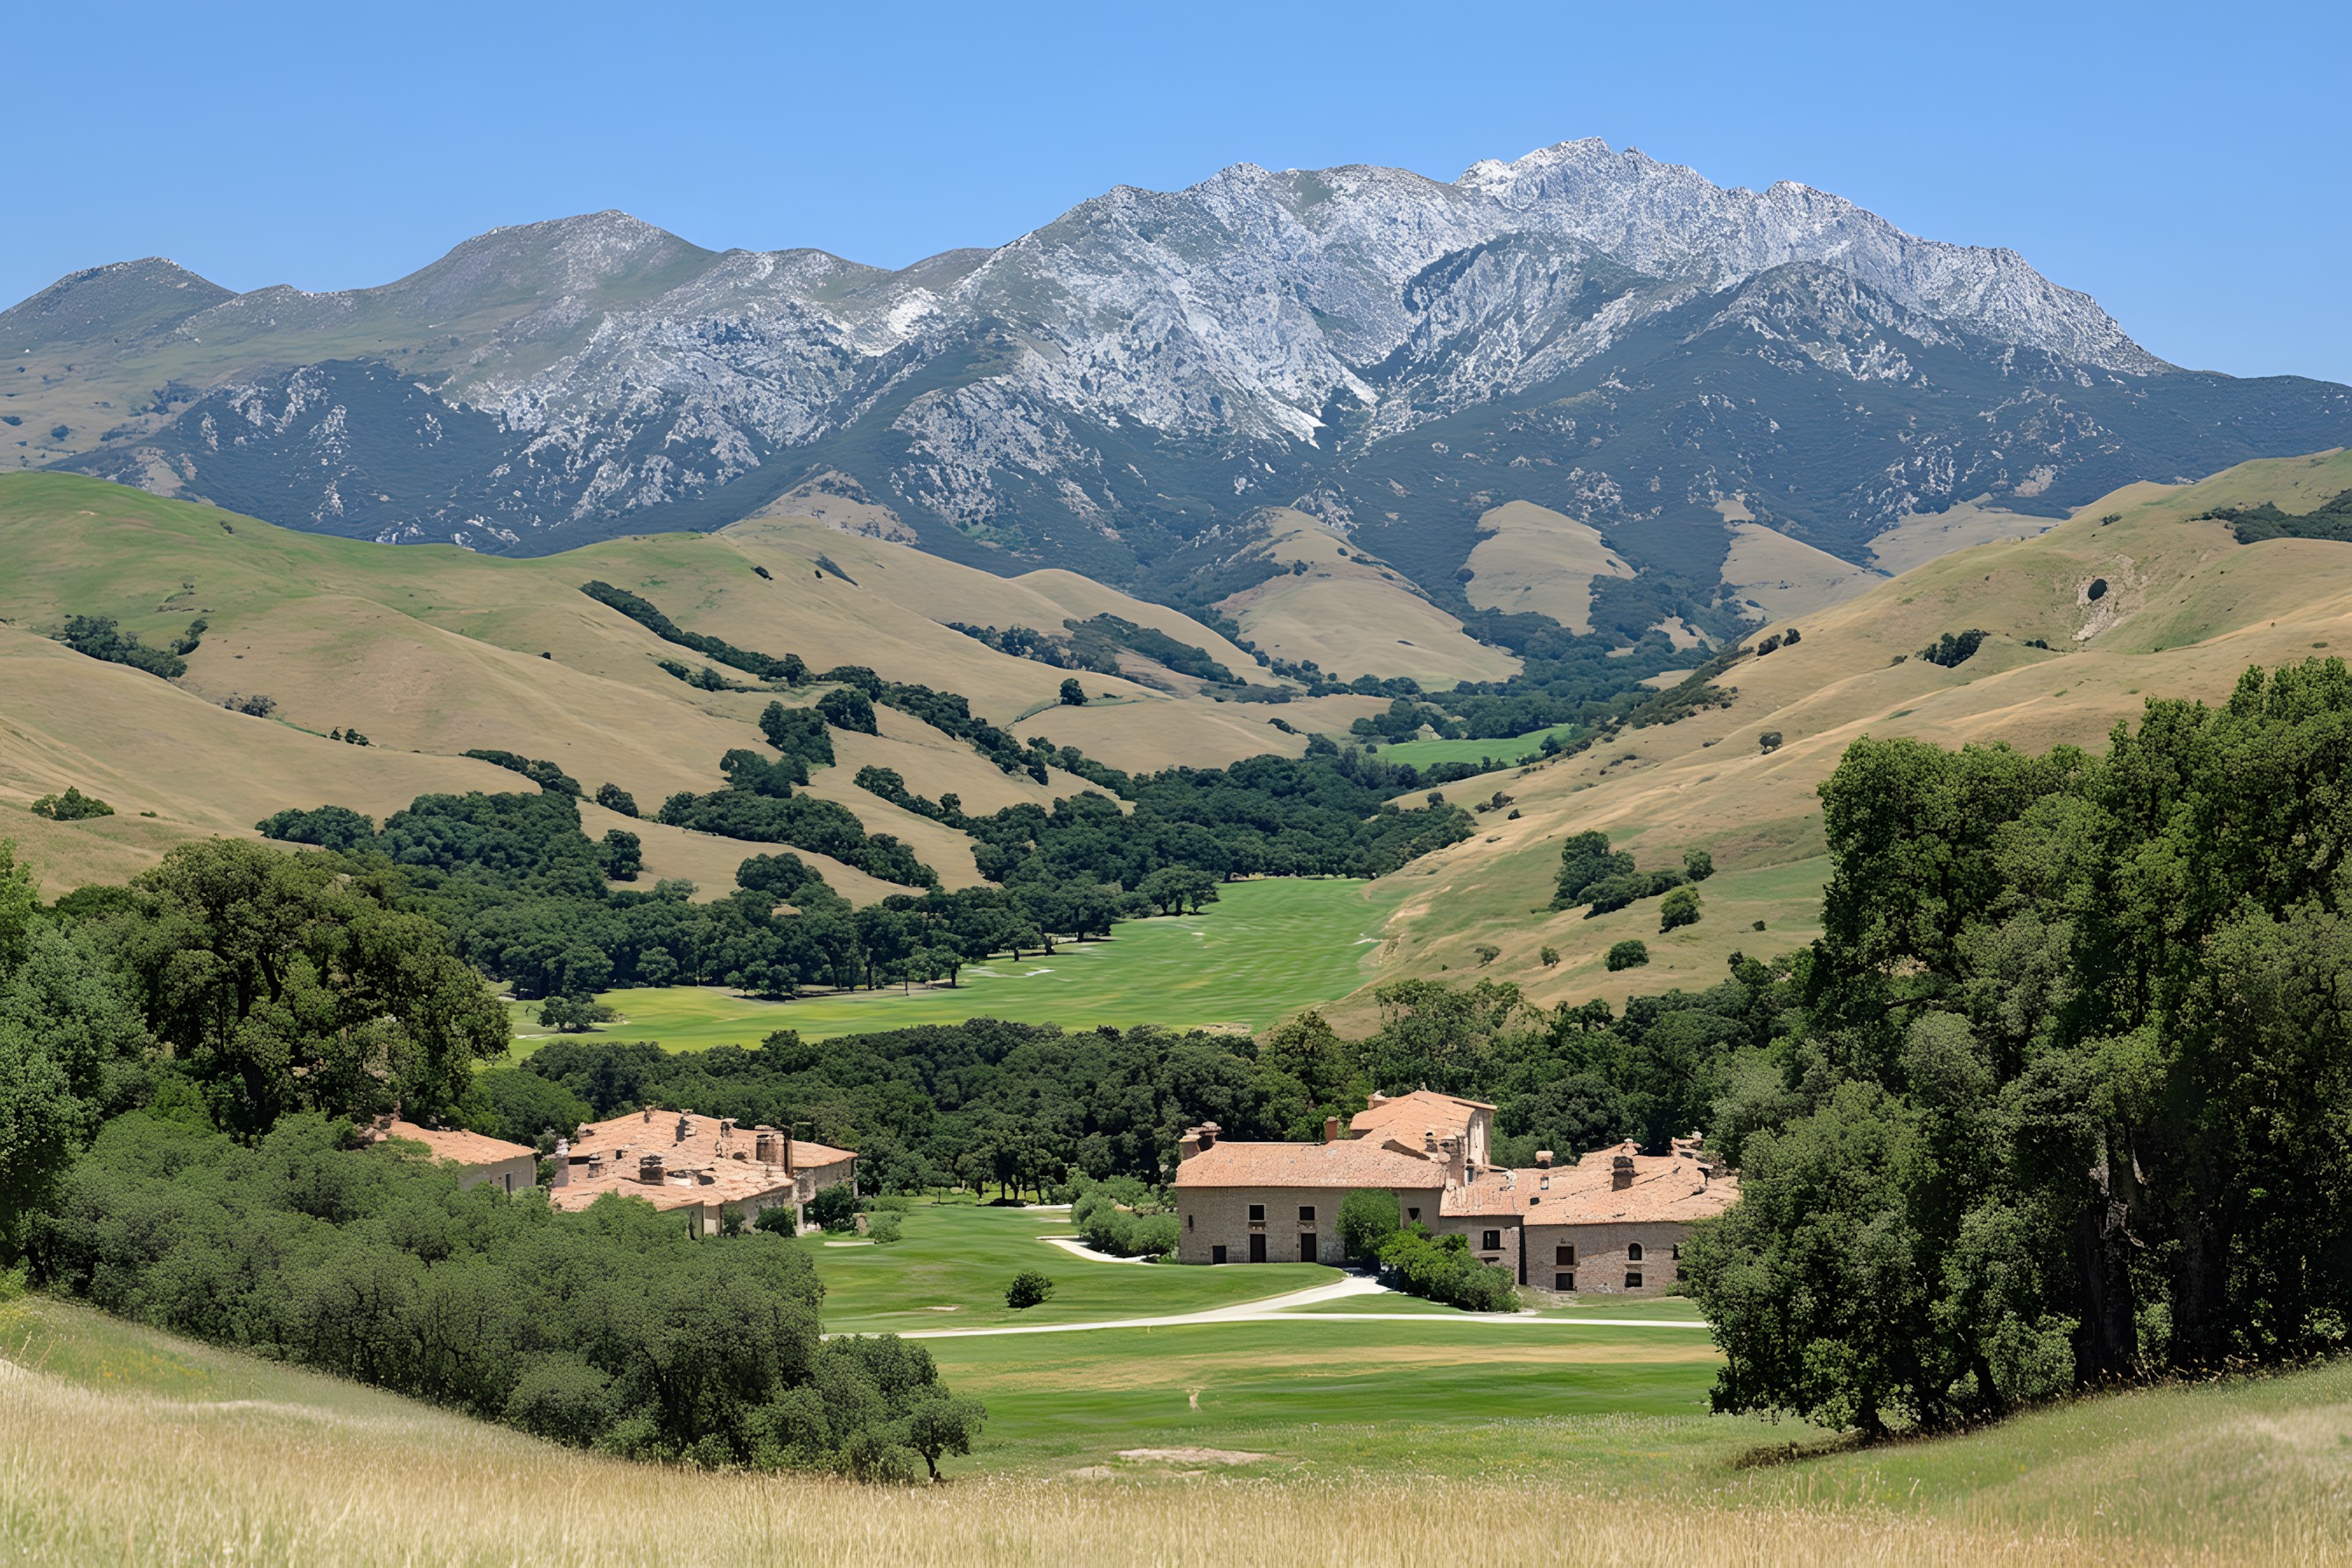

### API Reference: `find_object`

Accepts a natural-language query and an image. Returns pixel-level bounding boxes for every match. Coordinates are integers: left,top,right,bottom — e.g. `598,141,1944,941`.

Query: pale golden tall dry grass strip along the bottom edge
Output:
0,1363,2345,1568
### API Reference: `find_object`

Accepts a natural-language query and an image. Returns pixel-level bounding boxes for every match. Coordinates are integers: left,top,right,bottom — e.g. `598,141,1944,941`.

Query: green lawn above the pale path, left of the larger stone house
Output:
800,1199,1340,1333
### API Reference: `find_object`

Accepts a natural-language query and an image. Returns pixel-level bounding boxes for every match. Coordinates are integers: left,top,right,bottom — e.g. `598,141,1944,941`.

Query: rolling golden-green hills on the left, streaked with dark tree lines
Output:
0,475,1326,900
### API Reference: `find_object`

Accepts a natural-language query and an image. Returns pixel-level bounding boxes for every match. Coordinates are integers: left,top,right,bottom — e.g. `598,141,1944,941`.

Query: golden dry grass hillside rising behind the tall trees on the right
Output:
1334,452,2352,1020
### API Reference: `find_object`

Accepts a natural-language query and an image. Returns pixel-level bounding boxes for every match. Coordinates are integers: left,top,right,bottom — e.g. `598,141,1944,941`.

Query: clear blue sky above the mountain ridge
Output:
18,0,2352,381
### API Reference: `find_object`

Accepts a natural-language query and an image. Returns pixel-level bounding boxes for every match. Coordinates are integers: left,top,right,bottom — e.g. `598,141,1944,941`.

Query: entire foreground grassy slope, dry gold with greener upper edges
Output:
0,1300,2352,1565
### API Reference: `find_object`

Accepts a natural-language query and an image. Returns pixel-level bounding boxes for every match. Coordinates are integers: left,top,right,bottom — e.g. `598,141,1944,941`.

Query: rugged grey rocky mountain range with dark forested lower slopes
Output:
18,141,2352,609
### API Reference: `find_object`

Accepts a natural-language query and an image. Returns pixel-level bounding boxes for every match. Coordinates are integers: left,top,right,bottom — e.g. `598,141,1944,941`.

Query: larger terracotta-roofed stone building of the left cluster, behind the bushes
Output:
548,1107,858,1236
